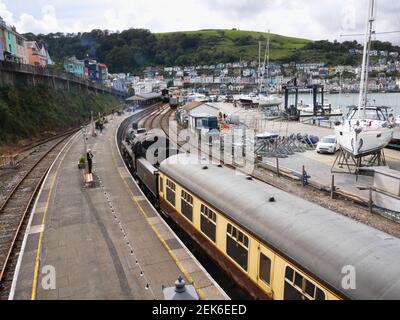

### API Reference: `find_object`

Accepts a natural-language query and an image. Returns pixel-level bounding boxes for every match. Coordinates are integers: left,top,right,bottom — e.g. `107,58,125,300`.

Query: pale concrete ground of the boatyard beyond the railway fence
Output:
177,103,400,216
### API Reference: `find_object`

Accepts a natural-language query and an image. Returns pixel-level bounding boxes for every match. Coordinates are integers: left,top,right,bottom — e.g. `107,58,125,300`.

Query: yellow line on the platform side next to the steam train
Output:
111,131,208,300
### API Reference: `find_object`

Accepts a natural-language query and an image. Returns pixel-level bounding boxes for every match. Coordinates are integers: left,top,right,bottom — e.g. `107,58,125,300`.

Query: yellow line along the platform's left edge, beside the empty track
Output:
31,135,77,300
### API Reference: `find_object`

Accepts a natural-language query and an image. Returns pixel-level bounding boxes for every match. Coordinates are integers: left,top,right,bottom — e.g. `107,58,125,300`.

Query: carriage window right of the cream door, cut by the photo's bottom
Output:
284,267,326,300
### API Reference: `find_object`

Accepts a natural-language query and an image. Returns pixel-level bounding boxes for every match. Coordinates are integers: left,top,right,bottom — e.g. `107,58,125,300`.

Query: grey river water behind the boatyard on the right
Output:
289,93,400,115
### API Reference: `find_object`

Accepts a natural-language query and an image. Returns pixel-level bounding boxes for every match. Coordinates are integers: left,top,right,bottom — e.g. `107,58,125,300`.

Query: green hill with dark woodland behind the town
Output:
25,29,310,72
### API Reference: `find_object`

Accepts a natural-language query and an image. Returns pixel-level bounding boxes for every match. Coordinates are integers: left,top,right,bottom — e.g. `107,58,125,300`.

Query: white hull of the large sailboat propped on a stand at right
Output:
335,126,393,156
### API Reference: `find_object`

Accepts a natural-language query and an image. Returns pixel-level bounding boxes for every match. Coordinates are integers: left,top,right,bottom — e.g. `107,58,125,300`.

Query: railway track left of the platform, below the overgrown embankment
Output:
0,130,77,300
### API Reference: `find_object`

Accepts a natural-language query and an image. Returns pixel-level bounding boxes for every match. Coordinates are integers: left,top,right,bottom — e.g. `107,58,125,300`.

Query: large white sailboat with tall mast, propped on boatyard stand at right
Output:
335,0,394,157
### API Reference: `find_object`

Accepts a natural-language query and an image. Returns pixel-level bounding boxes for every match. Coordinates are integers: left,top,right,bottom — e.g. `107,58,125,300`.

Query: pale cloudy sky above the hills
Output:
0,0,400,44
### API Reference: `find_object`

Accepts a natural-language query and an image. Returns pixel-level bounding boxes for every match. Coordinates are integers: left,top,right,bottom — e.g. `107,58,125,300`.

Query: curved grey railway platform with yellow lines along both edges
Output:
10,110,228,300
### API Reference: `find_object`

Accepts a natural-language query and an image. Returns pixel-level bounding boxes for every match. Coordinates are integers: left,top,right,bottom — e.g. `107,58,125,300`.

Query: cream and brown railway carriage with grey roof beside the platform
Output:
158,154,400,300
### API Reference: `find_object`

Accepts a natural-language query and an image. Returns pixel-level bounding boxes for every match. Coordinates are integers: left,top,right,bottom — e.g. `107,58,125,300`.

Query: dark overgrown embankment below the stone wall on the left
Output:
0,85,121,145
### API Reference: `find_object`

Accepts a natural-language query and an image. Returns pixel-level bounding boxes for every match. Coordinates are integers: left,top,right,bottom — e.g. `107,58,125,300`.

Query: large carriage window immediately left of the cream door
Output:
226,224,249,271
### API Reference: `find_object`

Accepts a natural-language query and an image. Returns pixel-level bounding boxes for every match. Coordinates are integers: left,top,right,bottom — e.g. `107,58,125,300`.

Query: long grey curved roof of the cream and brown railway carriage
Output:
160,154,400,300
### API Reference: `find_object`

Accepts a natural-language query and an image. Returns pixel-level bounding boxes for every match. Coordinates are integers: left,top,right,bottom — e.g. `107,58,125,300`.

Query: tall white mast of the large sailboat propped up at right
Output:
358,0,375,119
